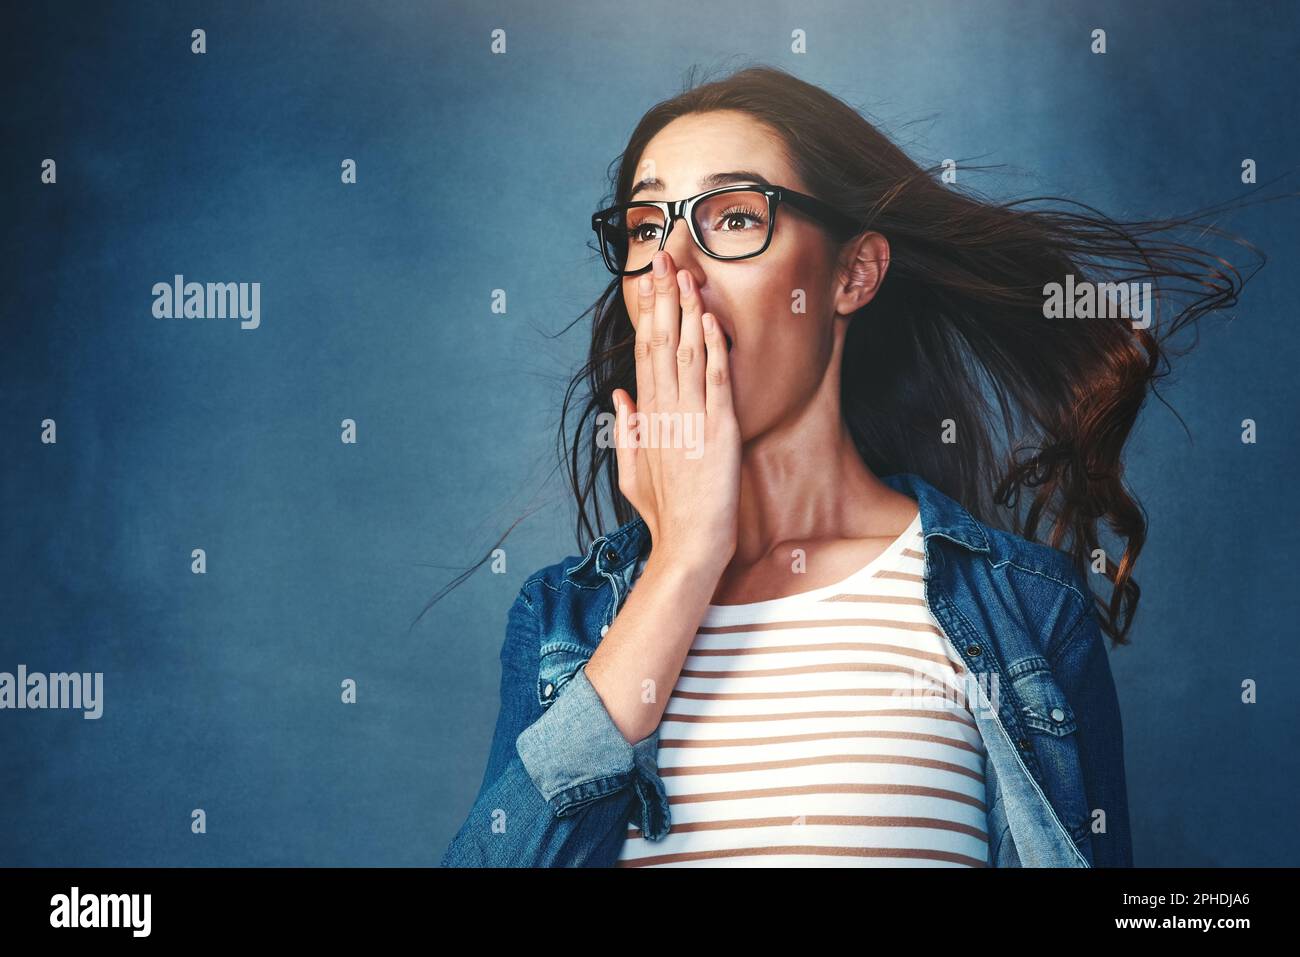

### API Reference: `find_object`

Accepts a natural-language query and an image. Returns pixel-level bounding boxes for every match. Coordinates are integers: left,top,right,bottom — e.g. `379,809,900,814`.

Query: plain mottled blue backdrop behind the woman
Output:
0,0,1300,866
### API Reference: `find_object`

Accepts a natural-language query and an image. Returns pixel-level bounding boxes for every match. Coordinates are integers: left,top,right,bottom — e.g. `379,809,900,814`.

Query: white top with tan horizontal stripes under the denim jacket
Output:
618,514,988,867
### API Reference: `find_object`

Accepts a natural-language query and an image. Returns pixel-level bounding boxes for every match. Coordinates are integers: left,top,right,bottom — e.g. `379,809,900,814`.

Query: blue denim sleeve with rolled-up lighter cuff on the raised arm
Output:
441,574,668,867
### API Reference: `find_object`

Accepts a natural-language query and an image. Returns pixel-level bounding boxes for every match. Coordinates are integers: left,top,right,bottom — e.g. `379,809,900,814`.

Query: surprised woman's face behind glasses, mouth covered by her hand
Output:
623,111,870,441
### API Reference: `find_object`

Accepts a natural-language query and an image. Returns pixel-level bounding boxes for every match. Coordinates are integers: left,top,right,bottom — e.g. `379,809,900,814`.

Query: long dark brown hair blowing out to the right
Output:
421,66,1289,645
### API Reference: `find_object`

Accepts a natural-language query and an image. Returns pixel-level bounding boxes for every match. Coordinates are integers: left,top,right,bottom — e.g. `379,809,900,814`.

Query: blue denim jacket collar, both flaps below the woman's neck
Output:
564,472,991,585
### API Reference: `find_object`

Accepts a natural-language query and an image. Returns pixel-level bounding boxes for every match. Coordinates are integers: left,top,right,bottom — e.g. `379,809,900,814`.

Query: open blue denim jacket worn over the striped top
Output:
441,472,1132,867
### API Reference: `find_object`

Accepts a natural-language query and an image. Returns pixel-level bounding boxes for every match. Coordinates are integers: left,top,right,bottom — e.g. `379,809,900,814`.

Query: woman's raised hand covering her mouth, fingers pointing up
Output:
614,252,740,575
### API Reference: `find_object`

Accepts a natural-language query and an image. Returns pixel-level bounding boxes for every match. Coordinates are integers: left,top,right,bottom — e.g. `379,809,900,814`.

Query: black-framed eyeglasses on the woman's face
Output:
592,186,861,276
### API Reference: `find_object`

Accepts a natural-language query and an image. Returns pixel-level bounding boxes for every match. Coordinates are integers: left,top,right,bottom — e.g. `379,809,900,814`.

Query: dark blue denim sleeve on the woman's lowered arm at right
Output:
1052,598,1132,867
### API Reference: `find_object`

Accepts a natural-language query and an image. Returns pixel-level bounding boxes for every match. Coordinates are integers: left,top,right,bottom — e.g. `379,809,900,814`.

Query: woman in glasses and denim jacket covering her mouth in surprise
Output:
442,68,1268,866
